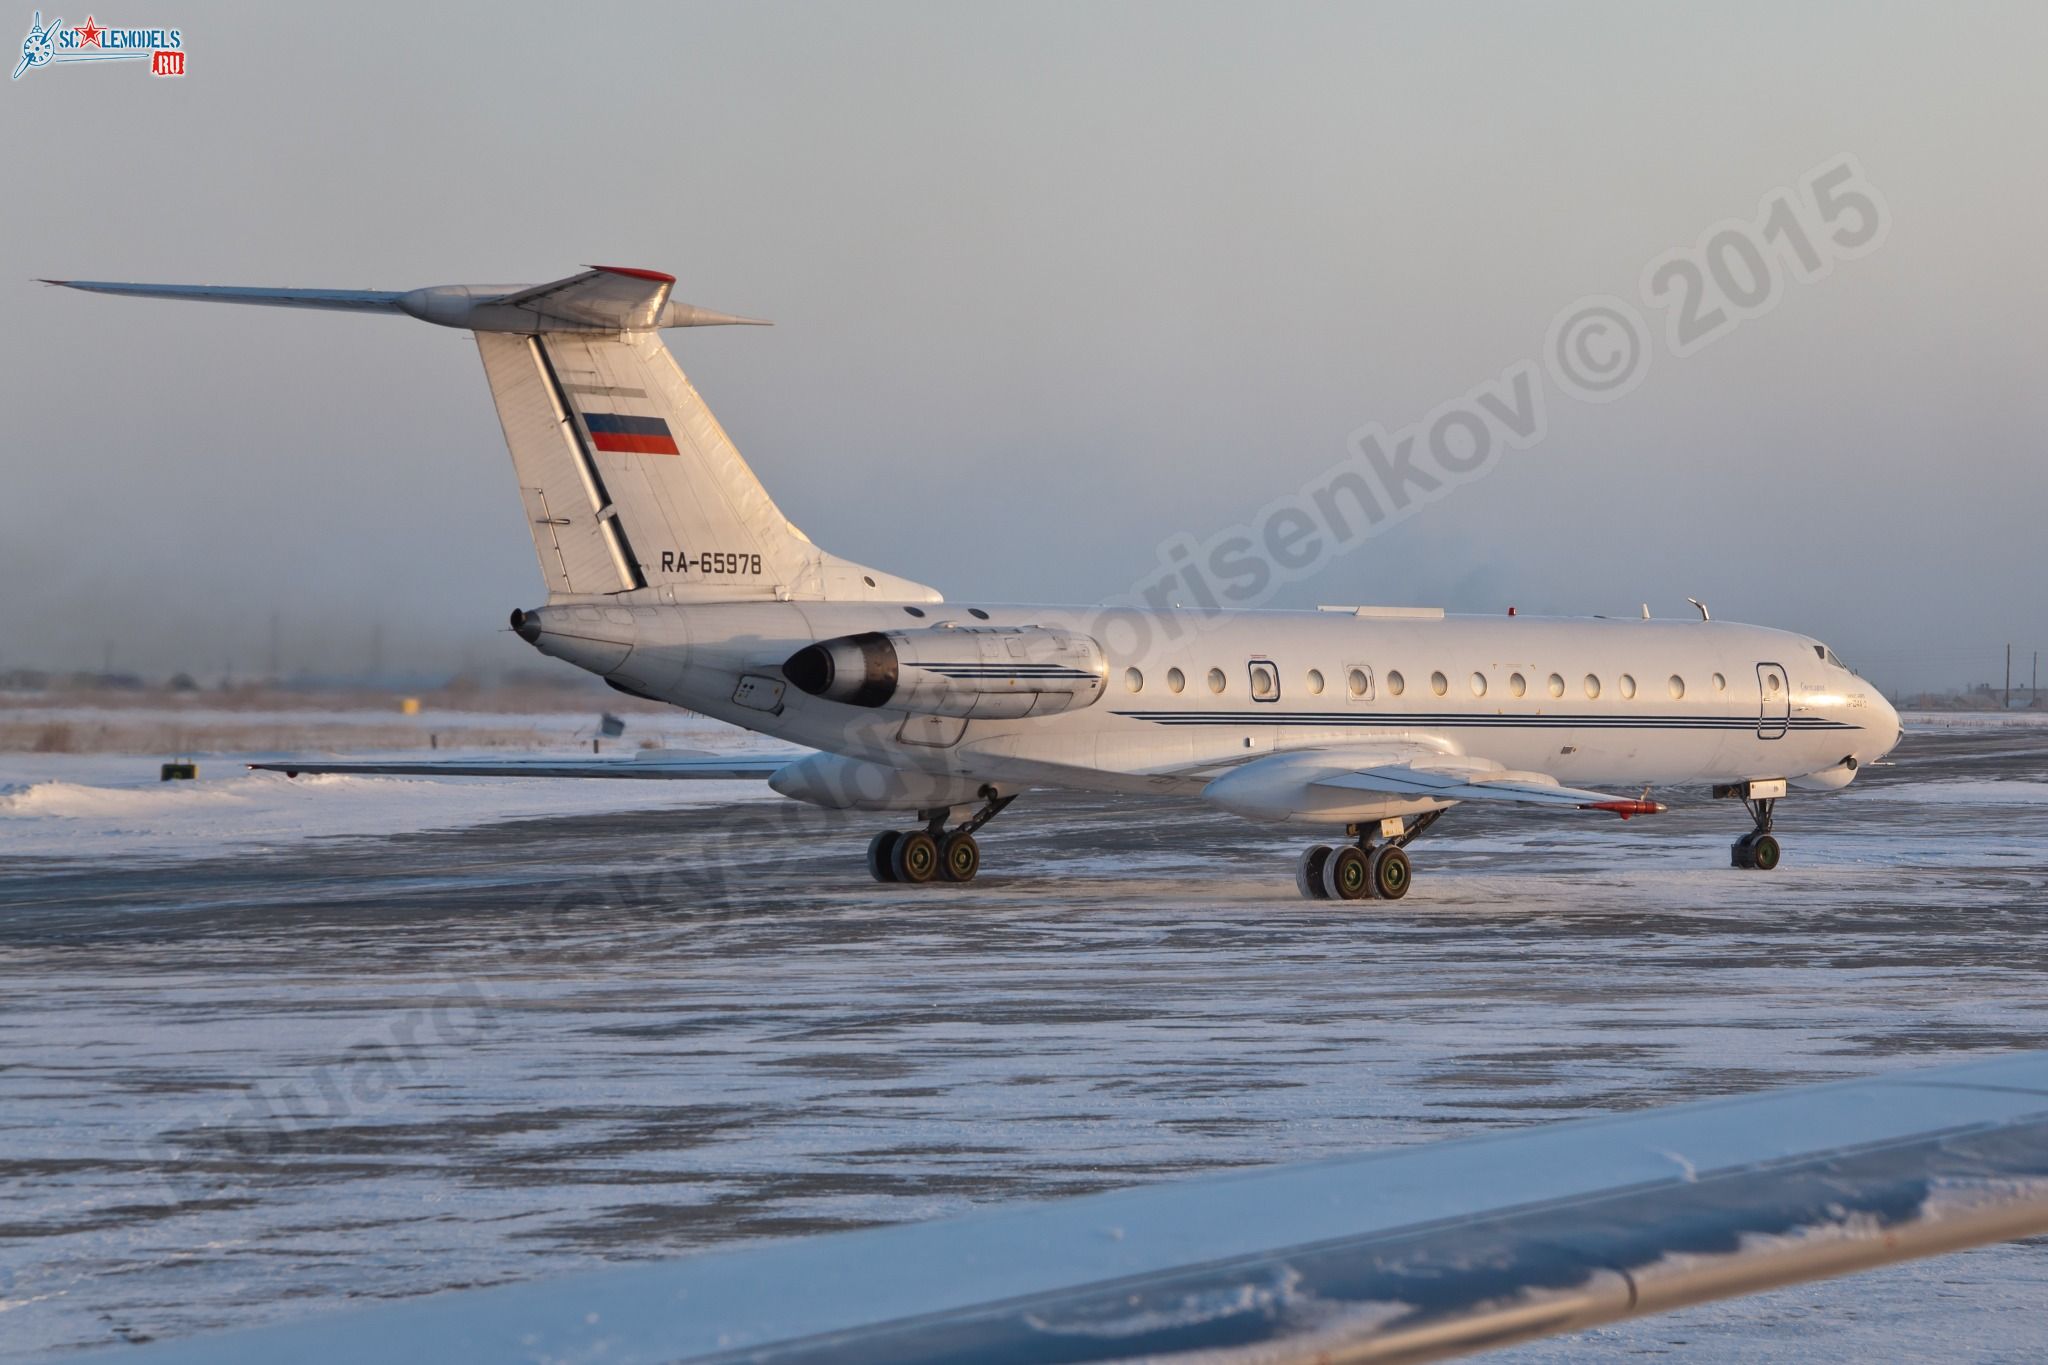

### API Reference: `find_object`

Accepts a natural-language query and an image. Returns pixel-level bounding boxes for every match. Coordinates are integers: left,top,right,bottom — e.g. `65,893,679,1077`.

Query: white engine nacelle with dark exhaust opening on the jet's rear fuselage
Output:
782,626,1110,720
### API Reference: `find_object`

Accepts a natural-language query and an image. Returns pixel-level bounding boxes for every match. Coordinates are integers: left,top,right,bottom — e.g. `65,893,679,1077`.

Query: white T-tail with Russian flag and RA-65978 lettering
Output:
45,266,938,604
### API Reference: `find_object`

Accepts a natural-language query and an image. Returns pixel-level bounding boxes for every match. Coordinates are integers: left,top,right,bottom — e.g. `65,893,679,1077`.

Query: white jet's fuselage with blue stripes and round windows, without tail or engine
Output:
535,598,1901,823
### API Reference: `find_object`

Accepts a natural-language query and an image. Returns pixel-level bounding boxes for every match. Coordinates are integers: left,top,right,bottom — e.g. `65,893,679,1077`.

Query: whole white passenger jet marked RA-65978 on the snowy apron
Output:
45,266,1903,900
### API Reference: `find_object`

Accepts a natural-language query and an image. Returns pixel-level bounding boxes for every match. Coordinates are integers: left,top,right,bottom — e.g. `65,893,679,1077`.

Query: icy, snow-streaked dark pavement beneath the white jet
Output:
0,726,2048,1361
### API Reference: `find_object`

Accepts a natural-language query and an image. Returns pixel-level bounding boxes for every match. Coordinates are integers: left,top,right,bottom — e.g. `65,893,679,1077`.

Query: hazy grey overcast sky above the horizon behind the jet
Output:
0,0,2048,690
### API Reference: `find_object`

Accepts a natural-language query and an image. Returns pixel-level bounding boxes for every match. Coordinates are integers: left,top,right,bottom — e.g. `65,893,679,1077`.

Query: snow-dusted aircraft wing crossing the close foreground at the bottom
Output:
88,1052,2048,1365
